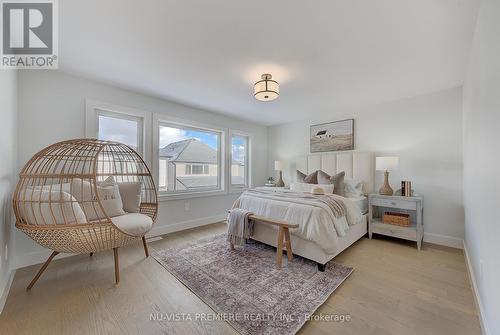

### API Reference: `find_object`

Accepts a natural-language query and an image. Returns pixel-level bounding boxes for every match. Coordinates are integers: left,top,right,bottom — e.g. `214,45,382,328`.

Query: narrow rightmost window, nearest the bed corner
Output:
231,135,249,188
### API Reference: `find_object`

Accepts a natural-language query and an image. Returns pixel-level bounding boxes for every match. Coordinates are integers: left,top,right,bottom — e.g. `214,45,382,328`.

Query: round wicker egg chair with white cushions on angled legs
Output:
13,139,158,290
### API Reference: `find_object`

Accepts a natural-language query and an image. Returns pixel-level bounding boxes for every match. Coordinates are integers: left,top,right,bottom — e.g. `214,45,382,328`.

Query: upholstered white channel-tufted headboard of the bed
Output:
294,151,375,194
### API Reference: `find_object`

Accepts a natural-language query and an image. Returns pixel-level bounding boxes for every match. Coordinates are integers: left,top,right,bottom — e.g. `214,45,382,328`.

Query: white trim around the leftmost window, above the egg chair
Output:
85,99,152,166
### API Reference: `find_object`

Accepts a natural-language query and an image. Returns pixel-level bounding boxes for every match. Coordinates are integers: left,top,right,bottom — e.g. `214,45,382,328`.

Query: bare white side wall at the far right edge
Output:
463,0,500,334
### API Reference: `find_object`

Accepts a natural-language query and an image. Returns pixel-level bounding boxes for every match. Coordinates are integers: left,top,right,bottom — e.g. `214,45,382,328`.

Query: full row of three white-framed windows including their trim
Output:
85,99,251,200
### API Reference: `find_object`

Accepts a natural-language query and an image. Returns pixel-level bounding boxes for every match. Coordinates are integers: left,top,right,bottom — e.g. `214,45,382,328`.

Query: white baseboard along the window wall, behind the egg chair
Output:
14,214,227,269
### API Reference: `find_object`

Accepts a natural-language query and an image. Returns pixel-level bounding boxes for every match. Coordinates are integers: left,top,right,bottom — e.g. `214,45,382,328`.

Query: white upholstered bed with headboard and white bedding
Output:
230,151,374,270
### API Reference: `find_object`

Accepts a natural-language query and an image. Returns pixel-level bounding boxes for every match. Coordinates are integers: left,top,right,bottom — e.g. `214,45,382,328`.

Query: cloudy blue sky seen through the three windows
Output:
99,115,246,163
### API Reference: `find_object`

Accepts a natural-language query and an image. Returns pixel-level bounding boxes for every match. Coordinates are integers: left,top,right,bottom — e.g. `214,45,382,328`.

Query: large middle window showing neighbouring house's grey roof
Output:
158,122,224,193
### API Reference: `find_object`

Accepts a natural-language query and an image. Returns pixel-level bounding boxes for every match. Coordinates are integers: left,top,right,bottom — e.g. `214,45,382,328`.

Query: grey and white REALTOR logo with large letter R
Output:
0,0,58,69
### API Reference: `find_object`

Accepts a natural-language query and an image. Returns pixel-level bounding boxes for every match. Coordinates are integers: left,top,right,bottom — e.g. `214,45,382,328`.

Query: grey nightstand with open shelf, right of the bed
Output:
368,194,424,250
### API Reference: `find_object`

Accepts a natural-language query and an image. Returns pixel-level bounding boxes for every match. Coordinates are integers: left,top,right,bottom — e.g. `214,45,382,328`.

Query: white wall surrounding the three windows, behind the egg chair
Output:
16,71,267,265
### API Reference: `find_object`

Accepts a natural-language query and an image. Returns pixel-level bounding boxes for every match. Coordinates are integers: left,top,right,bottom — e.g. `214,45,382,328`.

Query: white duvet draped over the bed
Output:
233,188,363,251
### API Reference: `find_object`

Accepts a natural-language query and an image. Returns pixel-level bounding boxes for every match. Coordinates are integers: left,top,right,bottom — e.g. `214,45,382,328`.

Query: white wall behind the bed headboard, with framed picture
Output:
268,88,464,247
